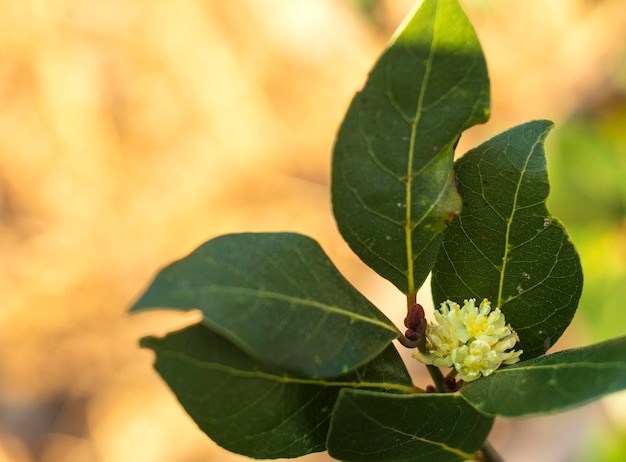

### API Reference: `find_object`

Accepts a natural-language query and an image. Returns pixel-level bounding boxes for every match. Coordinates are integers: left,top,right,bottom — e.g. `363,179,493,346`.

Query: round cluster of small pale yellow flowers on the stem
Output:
413,299,522,382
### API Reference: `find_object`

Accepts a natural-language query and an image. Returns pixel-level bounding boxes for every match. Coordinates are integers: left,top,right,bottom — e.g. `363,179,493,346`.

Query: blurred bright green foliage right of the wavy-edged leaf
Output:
548,104,626,341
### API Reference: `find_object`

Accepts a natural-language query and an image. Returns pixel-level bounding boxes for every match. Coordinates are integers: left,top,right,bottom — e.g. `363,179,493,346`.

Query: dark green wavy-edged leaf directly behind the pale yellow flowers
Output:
432,120,583,359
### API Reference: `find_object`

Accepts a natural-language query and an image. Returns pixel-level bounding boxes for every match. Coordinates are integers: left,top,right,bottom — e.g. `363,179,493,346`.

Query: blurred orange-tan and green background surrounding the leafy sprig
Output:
0,0,626,462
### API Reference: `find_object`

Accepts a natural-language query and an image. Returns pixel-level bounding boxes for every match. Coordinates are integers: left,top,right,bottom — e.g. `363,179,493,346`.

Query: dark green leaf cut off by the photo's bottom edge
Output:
328,389,493,462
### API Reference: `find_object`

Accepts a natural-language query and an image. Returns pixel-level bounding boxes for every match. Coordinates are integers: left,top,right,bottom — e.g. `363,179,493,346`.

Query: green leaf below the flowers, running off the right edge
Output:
461,337,626,417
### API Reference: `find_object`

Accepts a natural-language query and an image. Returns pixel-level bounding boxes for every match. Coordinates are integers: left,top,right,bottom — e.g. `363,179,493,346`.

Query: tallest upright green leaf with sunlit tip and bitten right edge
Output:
332,0,489,294
